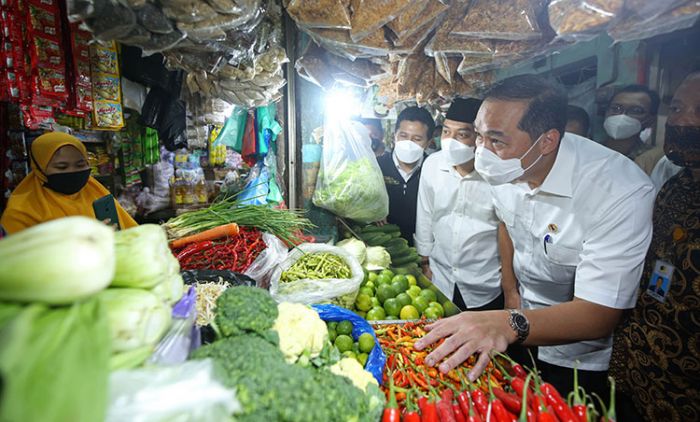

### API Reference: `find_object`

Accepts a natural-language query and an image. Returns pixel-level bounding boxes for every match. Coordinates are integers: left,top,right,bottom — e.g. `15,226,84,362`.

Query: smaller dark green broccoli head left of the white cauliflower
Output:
214,286,278,338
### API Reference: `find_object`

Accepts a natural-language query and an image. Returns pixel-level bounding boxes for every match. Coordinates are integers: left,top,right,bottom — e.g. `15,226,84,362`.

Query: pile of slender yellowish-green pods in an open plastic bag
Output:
280,252,352,283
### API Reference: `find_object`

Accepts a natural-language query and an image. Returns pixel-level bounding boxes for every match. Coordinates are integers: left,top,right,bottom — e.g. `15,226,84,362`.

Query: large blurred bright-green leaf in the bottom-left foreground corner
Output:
0,299,110,422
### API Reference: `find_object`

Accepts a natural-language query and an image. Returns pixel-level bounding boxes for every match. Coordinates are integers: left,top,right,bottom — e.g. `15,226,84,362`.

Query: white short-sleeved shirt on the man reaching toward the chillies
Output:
486,133,655,371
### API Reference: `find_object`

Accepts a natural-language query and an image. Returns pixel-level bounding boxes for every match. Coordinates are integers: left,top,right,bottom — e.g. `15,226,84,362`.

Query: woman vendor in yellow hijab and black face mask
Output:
0,132,137,234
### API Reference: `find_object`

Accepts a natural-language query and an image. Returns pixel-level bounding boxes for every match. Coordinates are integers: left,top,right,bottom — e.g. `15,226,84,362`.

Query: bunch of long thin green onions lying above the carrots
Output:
164,196,314,245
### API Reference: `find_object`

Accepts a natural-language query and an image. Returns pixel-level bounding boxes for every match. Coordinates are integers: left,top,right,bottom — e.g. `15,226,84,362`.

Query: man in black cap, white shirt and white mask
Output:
416,98,503,311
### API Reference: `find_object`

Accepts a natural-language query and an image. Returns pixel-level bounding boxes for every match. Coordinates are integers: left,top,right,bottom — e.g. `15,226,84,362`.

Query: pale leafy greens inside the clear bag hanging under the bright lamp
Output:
313,158,389,223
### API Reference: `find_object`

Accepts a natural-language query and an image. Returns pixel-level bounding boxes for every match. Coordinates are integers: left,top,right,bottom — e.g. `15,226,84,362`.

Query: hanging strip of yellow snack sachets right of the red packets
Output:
90,42,124,130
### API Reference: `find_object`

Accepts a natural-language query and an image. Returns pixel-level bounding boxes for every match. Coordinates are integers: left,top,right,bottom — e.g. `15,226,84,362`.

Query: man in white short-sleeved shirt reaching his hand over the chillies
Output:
416,75,655,400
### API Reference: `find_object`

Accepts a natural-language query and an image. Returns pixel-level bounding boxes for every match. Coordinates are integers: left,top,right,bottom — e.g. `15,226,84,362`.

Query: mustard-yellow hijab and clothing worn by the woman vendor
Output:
0,132,137,233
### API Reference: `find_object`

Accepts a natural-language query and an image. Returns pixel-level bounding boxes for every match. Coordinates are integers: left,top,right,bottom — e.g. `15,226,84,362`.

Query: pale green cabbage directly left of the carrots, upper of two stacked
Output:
111,224,174,289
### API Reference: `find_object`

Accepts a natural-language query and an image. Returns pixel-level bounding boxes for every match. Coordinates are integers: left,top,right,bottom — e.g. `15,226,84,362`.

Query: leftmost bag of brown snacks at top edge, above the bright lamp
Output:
287,0,350,29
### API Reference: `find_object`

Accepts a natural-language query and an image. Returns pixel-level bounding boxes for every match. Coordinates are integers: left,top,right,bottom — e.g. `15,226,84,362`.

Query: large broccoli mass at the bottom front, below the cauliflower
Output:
192,334,384,422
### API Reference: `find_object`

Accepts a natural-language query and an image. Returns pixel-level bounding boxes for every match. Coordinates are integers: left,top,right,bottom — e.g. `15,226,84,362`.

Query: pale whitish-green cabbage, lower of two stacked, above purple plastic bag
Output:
98,289,171,352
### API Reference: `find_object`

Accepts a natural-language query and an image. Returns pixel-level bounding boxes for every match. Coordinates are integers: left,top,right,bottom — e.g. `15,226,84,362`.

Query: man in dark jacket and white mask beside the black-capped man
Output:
377,107,435,245
